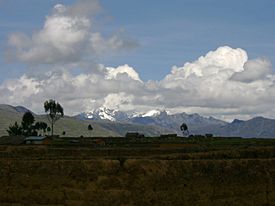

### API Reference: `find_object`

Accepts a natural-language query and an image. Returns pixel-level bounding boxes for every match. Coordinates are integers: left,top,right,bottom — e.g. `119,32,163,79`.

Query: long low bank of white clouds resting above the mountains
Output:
0,46,275,119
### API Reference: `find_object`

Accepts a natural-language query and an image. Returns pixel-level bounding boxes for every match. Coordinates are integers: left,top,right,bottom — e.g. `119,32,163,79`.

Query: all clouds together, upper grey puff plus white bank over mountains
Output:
0,0,275,120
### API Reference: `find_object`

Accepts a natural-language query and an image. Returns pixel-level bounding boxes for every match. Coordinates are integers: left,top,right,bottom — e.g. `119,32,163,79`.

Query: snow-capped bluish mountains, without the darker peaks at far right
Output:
76,107,227,134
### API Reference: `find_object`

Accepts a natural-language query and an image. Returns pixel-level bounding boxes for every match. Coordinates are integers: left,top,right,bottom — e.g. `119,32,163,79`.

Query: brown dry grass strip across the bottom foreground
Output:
0,156,275,206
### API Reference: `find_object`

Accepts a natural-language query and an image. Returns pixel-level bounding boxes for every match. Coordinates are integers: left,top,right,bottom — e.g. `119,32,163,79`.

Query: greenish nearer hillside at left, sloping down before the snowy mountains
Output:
0,105,175,137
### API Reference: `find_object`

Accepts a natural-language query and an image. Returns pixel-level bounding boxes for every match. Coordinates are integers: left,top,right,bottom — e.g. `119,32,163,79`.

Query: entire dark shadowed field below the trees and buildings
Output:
0,137,275,206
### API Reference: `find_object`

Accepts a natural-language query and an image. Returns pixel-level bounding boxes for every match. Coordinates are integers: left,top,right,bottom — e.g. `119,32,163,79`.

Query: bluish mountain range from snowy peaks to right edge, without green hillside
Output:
76,107,275,137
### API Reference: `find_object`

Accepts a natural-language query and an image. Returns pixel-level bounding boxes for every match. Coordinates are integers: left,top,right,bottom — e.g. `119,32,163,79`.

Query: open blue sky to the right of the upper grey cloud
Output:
103,0,275,79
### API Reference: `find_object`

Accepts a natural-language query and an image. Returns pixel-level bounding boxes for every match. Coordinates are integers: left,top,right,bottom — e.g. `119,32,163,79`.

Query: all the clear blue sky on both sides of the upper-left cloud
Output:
0,0,275,81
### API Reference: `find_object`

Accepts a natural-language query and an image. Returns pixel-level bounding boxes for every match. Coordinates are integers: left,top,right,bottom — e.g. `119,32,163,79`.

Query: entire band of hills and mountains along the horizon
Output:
0,104,275,138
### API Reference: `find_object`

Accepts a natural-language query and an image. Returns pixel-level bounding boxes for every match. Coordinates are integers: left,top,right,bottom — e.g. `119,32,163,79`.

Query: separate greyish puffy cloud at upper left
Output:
7,0,137,65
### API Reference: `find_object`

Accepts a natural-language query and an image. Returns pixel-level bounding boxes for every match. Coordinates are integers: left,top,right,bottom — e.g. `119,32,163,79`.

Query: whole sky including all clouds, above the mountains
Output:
0,0,275,121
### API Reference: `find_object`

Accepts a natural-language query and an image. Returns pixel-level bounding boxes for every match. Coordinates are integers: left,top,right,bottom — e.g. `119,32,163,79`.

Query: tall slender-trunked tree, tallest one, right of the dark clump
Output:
44,99,64,136
